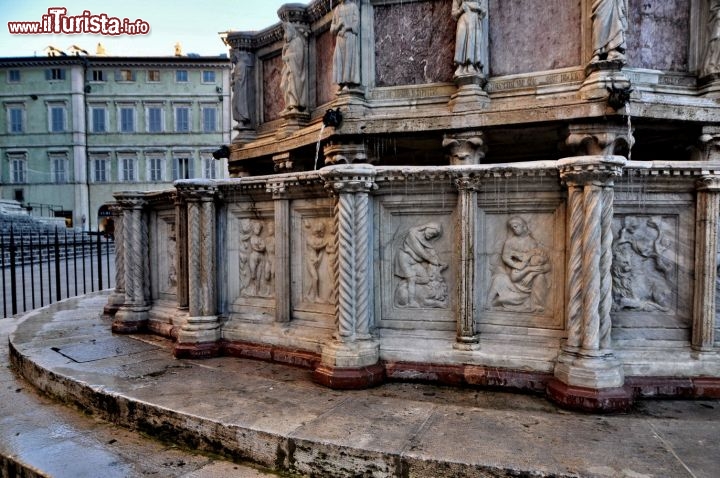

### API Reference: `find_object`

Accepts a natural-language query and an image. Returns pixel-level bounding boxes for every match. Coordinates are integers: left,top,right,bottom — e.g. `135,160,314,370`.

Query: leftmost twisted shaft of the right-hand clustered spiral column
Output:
567,185,584,347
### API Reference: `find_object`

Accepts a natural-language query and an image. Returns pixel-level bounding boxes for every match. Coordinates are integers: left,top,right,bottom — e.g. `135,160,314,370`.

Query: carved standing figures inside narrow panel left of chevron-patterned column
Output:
303,218,337,304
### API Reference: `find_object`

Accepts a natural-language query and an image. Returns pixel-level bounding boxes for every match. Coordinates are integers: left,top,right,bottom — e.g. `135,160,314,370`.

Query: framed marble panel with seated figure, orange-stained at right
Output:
476,193,566,337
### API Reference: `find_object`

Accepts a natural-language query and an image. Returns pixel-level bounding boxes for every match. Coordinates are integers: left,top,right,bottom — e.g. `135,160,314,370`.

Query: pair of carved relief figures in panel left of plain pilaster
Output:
238,219,275,297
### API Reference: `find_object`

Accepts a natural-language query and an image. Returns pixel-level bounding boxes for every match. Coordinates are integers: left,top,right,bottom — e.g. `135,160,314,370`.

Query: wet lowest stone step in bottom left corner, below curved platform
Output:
0,319,278,478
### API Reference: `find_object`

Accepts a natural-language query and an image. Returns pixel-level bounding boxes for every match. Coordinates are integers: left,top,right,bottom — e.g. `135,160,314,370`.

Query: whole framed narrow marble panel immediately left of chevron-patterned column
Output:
290,198,337,327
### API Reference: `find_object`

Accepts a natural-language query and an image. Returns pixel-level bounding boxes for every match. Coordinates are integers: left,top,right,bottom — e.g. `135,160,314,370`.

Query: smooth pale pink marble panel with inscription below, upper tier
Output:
488,0,582,76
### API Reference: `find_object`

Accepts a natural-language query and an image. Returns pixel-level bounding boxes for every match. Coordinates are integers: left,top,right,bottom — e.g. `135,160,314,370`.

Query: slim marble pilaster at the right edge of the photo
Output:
692,174,720,352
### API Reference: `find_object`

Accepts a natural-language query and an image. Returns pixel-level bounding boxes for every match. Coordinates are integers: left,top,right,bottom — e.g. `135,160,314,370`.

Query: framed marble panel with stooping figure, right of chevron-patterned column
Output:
374,196,458,333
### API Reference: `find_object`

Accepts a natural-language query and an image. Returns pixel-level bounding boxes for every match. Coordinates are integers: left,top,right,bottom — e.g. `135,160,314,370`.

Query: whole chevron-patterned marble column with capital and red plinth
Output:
314,165,384,388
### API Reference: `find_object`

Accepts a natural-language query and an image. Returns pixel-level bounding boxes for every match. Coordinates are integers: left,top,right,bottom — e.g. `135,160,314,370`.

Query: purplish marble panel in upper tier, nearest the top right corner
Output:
627,0,690,71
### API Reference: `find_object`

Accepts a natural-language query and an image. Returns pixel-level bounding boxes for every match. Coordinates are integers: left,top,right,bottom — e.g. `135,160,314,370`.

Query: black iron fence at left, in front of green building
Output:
0,227,115,317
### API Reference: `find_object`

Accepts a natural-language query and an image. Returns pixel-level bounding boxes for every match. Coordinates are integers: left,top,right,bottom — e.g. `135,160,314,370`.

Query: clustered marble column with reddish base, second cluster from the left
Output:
174,183,220,358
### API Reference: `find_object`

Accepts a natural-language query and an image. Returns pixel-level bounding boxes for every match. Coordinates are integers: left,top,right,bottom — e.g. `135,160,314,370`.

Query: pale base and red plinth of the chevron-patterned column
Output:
312,340,385,390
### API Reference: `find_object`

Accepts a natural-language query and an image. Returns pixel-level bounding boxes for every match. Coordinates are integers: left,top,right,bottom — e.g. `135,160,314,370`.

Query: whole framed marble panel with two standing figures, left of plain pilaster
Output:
226,201,275,321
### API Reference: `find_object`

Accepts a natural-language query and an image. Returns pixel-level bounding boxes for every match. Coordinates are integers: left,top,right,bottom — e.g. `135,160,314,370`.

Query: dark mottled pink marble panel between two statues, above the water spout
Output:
375,0,455,86
